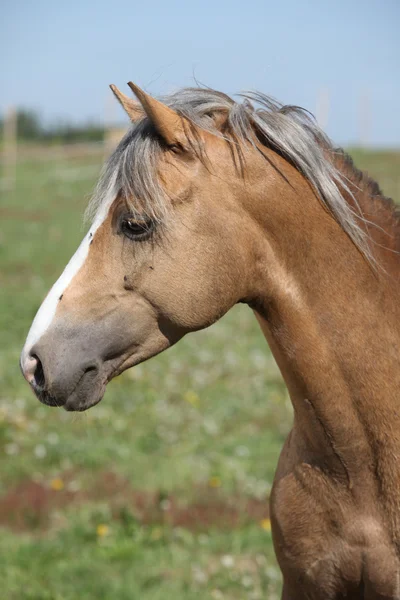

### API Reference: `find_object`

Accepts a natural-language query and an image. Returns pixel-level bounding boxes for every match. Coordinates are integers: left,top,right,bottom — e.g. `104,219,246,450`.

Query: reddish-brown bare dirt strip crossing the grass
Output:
0,472,268,531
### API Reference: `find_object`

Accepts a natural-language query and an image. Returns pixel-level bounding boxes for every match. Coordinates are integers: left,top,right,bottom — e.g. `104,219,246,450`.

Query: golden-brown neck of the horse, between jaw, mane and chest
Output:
247,150,400,496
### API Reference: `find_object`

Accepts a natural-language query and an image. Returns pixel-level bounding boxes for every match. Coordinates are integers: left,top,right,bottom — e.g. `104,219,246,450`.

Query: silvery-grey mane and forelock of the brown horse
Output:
88,88,390,262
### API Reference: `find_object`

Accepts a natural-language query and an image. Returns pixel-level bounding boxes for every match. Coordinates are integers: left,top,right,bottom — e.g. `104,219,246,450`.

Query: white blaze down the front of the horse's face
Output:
21,198,112,366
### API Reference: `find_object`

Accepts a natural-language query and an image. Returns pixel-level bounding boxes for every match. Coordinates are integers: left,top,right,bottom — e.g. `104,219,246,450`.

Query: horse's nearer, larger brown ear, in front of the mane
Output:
128,81,187,148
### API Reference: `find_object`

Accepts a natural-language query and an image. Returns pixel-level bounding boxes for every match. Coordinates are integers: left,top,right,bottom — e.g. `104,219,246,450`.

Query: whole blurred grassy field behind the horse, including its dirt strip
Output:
0,146,400,600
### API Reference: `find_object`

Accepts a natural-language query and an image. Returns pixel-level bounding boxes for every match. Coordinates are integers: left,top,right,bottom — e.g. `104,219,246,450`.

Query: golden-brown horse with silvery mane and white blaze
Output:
20,82,400,600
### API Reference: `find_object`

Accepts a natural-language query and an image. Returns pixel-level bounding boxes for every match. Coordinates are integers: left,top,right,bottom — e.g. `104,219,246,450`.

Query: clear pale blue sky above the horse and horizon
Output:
0,0,400,146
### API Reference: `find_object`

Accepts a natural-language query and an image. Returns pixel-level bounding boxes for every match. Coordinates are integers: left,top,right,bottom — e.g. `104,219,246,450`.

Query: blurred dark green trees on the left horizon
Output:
0,108,104,144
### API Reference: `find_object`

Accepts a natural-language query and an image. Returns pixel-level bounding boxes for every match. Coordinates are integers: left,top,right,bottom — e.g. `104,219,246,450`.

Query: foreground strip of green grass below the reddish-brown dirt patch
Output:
0,508,279,600
